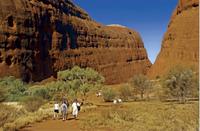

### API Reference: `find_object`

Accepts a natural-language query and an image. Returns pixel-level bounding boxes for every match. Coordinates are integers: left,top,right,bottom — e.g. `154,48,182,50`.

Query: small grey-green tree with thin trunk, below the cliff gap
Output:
131,74,151,99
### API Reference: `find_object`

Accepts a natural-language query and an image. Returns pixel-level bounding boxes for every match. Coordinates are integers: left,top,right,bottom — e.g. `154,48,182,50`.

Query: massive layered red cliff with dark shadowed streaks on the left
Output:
0,0,151,84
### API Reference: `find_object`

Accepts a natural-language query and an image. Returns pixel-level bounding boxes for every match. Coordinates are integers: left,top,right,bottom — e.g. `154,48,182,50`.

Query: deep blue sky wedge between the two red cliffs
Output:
72,0,178,63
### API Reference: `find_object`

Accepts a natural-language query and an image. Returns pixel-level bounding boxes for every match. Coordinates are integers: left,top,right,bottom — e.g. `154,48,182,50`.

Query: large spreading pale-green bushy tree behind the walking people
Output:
58,66,105,99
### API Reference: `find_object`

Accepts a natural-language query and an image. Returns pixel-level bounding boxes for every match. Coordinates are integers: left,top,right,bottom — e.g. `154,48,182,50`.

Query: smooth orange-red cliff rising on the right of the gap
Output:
148,0,199,78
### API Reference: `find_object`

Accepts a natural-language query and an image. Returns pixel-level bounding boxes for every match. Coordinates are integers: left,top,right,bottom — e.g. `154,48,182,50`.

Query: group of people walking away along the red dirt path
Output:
54,99,82,121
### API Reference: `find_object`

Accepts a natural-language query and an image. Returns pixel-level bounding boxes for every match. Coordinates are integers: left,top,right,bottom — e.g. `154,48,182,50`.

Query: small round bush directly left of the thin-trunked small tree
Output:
119,85,133,101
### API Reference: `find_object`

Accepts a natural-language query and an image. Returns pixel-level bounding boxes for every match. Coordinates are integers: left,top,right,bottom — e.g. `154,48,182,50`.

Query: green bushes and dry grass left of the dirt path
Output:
0,66,104,131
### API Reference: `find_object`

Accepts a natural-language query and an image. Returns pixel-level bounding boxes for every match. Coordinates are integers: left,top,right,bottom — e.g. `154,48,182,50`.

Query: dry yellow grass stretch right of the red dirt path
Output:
81,102,198,131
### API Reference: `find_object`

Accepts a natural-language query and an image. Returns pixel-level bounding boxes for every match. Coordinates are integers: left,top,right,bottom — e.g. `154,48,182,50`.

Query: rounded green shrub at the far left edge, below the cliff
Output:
0,76,27,101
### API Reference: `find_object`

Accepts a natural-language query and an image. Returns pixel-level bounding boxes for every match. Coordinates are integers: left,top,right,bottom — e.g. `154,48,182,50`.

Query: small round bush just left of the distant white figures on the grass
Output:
102,88,116,102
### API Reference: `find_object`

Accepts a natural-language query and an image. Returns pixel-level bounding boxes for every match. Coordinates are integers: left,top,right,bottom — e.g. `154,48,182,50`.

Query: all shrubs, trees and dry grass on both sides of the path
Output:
0,66,198,131
